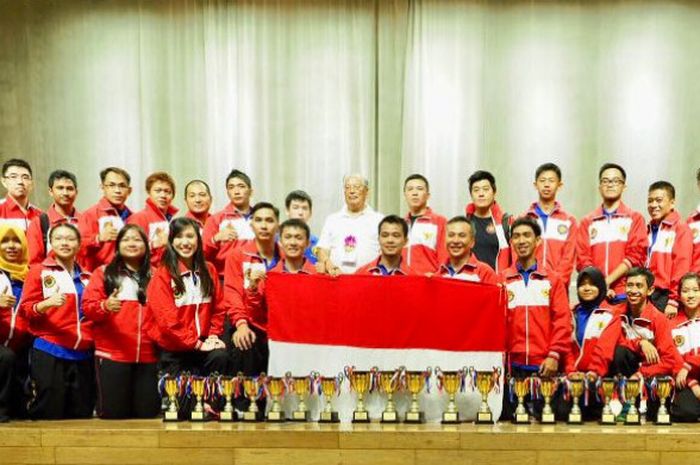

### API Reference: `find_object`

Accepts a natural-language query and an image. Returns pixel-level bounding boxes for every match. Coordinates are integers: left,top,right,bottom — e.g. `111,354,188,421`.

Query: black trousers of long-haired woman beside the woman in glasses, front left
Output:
95,357,160,419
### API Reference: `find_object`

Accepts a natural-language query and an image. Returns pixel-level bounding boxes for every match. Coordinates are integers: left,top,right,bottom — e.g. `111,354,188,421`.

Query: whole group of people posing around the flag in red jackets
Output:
0,159,700,421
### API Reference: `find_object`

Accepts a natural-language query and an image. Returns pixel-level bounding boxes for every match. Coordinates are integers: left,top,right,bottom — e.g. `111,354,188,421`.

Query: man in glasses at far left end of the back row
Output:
0,158,41,232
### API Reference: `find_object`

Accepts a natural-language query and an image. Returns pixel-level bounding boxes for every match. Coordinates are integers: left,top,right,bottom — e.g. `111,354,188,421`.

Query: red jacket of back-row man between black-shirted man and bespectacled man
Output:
525,202,577,284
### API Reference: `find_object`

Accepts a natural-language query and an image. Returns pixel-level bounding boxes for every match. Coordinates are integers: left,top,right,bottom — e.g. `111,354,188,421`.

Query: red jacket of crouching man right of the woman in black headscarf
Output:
618,302,683,377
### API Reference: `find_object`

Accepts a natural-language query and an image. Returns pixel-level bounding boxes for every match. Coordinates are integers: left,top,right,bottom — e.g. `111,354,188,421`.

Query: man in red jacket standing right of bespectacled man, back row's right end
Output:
646,181,693,318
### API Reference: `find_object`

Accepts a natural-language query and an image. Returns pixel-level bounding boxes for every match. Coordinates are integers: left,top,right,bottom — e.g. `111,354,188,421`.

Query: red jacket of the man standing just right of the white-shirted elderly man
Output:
404,207,447,274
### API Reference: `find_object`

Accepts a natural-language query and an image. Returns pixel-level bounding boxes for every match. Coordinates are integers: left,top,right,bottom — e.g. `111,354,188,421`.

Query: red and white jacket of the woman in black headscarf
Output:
564,306,622,376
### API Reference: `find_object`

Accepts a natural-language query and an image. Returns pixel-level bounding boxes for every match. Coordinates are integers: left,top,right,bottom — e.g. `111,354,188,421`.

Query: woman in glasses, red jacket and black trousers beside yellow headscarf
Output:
21,223,95,419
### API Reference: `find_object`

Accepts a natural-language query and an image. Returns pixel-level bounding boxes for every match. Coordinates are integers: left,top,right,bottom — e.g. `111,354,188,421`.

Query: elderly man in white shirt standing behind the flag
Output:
316,174,384,275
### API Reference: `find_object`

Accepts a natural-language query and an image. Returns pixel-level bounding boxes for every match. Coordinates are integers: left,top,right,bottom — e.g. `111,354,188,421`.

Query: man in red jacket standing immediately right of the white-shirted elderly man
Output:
403,174,447,274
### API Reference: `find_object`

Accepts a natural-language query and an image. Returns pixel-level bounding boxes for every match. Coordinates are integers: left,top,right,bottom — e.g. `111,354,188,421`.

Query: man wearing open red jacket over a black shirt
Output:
466,170,513,273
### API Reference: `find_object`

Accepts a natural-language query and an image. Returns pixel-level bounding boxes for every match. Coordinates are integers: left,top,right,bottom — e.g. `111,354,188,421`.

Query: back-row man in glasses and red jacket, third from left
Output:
78,166,131,271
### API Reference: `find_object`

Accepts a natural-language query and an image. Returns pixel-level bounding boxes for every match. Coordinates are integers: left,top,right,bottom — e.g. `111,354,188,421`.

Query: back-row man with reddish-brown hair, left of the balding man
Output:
127,171,178,266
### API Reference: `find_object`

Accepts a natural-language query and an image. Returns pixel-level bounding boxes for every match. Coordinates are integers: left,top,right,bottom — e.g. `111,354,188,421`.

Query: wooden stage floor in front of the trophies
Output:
0,420,700,465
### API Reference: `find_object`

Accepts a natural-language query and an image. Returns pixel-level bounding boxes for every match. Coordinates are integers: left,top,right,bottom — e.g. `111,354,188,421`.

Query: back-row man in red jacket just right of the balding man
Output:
202,170,254,278
